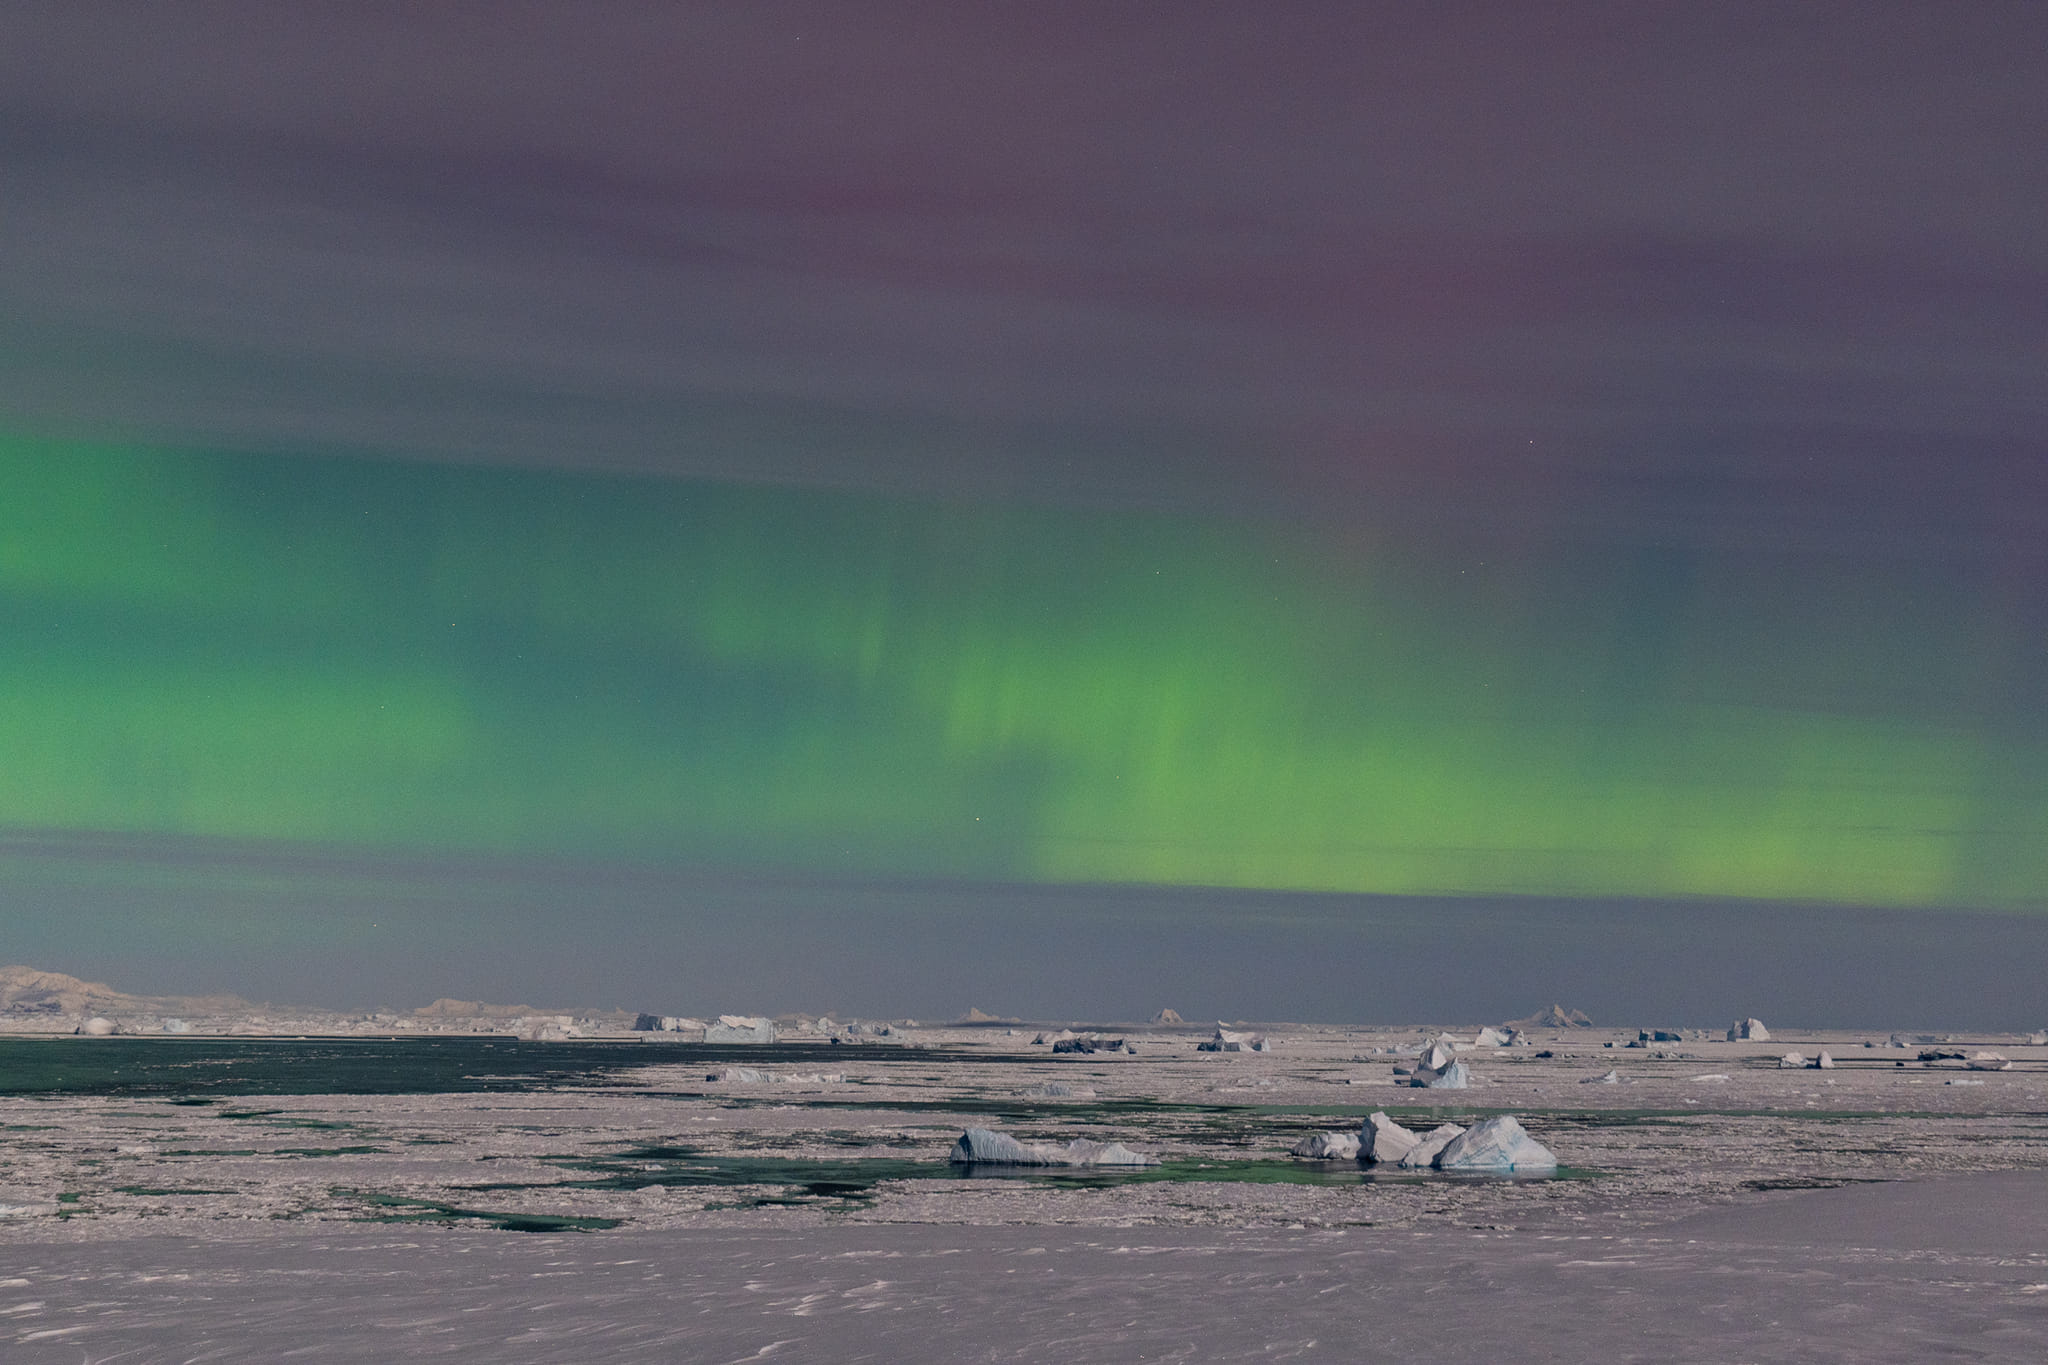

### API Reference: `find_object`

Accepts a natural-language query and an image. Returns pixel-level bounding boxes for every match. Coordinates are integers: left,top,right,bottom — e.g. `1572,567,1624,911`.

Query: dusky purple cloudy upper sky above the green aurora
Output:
0,0,2048,557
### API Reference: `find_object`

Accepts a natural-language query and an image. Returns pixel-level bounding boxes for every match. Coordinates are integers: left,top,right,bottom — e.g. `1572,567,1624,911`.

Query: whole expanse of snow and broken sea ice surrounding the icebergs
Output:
0,1027,2048,1365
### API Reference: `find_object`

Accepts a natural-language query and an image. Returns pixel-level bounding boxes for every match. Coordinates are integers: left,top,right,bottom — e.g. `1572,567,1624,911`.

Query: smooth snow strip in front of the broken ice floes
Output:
0,1173,2048,1365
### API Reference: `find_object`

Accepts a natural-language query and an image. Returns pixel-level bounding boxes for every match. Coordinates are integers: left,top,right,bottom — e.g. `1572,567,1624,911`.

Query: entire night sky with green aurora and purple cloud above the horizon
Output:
0,2,2048,1027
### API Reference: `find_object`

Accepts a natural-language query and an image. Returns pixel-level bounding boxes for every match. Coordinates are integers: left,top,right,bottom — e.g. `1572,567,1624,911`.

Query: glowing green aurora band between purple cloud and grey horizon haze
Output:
0,438,2048,909
